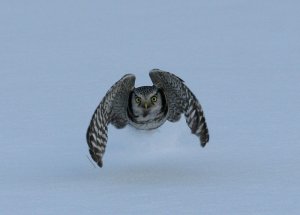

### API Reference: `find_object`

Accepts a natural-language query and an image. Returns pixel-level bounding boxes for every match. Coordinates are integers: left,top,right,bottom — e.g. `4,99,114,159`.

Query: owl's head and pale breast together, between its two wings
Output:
127,86,168,130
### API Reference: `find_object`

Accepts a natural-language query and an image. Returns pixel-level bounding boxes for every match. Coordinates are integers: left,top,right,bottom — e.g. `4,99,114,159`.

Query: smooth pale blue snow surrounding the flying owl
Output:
0,0,300,215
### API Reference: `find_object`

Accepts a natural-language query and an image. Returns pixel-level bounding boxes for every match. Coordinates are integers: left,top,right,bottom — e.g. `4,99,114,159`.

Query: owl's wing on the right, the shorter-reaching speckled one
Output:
149,69,209,147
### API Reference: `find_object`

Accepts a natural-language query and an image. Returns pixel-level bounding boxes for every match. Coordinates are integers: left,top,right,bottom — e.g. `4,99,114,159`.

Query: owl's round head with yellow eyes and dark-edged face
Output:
129,86,166,121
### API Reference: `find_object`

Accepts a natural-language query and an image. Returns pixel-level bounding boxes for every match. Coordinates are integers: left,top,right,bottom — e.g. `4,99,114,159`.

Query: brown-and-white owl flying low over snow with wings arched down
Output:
86,69,209,167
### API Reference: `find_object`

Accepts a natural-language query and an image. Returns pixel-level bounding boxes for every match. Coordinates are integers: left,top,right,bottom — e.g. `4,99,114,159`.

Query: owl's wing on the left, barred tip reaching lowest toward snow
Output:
86,74,135,167
